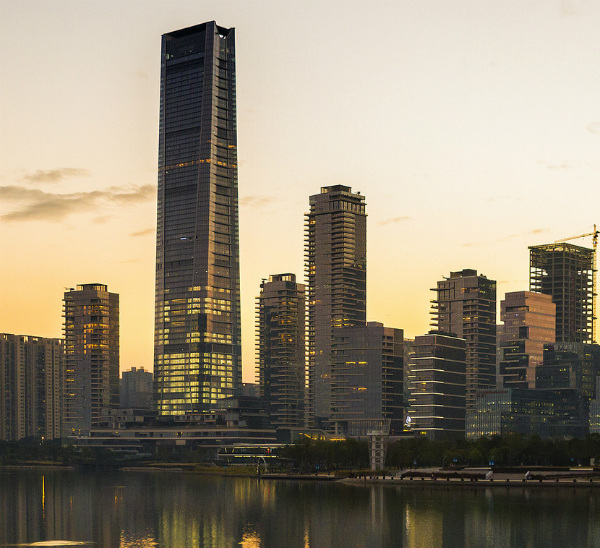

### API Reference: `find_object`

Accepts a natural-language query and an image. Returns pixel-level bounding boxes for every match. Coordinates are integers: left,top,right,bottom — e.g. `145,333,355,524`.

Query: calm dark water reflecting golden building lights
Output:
0,469,600,548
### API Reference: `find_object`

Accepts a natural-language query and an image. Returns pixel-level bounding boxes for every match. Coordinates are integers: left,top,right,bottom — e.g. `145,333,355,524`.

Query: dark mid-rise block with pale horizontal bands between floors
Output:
408,331,467,440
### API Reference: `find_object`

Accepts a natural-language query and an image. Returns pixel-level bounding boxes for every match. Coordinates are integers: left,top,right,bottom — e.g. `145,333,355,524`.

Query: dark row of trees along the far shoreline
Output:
0,433,600,473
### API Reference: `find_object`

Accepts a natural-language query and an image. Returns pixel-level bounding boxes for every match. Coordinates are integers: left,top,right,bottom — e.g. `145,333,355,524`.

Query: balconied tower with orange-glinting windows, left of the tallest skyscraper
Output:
63,283,119,436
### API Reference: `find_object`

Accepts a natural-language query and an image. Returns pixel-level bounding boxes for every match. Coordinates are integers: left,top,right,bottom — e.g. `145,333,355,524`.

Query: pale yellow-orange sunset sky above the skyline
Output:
0,0,600,382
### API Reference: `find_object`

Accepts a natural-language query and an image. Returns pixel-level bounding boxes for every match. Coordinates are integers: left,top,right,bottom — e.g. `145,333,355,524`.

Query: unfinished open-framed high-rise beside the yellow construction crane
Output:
529,242,596,343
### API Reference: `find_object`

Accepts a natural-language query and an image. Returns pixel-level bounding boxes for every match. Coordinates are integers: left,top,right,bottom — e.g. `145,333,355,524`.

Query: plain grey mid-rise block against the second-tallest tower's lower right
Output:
330,322,404,436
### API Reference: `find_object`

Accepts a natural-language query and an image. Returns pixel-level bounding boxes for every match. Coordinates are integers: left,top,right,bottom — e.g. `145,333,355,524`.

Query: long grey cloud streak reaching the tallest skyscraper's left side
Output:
0,185,156,222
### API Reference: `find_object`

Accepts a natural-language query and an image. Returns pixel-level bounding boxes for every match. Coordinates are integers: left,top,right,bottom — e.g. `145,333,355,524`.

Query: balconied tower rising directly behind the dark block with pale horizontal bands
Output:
432,269,496,416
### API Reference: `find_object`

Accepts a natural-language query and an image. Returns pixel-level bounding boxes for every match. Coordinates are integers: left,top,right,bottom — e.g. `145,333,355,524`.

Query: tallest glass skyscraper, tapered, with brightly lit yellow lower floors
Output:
154,21,242,415
